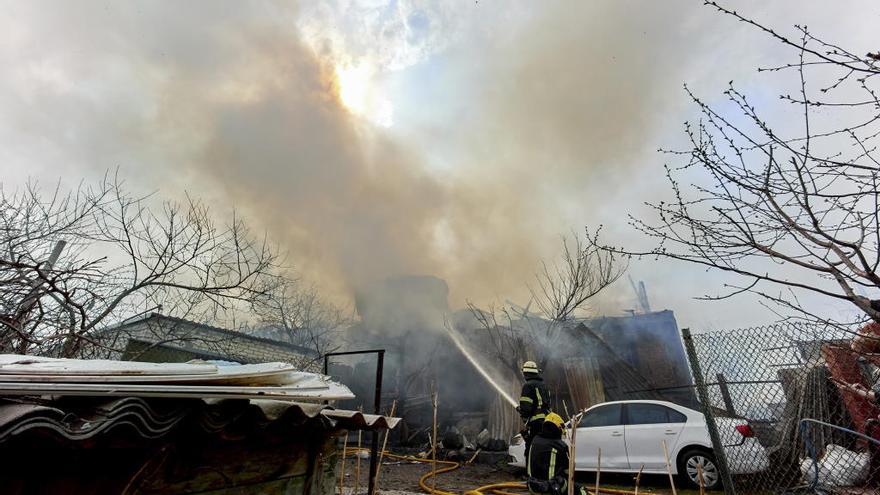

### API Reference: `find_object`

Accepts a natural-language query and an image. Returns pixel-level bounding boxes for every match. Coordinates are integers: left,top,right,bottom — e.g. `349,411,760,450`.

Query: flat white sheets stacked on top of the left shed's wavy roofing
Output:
0,354,354,401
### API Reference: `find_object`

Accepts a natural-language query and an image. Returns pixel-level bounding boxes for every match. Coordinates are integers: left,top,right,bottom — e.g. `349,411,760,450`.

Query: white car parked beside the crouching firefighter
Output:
508,400,770,489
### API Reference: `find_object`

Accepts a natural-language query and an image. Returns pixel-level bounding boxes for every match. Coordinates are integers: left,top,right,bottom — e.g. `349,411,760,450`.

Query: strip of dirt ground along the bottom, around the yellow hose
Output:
334,458,712,495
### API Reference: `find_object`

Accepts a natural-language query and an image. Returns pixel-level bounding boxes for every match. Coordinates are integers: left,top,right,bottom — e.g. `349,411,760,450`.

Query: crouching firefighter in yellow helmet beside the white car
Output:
526,413,586,495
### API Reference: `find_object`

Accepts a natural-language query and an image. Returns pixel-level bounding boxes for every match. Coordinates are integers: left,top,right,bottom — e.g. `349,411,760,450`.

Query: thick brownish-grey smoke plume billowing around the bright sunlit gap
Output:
3,2,708,306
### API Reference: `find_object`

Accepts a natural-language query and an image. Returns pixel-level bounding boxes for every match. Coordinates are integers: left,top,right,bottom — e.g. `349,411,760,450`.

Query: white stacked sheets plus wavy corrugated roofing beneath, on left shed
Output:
0,354,398,446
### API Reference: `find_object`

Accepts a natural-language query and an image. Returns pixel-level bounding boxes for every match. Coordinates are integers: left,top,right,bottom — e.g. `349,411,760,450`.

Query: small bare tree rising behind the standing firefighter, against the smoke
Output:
468,231,626,375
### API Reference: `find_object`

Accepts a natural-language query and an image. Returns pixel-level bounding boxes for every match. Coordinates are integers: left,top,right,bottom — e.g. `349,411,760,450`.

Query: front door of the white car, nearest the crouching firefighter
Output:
574,404,629,471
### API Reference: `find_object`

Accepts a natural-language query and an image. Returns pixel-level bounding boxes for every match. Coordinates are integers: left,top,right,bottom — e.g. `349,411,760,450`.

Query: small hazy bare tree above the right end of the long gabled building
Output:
249,278,352,356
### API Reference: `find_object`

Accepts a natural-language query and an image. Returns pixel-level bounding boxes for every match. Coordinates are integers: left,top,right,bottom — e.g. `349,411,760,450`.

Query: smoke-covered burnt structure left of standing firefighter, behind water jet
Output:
340,276,494,445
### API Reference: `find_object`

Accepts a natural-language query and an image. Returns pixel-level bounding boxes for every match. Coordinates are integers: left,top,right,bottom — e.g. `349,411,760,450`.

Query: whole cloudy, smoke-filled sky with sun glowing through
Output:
0,0,880,331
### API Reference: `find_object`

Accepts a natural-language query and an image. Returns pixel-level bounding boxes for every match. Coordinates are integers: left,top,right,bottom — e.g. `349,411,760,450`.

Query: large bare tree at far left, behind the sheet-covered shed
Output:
0,177,276,356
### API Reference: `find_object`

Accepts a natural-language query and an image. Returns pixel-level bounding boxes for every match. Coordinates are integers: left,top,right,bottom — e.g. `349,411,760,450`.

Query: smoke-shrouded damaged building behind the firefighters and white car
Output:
330,276,696,450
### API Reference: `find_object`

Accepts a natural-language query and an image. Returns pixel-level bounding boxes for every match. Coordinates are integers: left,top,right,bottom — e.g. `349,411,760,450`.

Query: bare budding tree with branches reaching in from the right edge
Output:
584,2,880,330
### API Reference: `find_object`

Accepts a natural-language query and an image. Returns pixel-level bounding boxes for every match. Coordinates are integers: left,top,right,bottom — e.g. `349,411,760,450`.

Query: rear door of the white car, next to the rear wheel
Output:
624,402,687,471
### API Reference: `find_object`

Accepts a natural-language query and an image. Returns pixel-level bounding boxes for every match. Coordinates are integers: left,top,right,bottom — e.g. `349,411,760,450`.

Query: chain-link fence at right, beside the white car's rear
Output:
683,324,880,493
